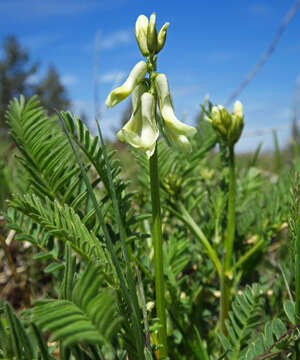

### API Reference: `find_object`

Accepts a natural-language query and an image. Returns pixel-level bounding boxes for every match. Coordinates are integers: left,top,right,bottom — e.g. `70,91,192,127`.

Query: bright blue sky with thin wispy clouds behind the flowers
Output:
0,0,300,150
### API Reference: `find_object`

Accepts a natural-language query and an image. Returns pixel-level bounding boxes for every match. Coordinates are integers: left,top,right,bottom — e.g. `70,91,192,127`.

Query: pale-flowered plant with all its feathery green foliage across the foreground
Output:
0,10,300,360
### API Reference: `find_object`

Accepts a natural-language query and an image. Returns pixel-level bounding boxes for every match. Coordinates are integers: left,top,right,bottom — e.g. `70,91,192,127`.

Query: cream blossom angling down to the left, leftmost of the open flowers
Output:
105,61,147,107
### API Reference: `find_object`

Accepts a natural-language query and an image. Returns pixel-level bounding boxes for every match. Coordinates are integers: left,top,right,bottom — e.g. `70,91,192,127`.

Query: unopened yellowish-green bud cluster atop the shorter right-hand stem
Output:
206,101,244,146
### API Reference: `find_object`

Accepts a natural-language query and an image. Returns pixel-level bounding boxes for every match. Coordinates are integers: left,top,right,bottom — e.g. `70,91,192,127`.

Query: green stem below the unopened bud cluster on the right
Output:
221,145,235,334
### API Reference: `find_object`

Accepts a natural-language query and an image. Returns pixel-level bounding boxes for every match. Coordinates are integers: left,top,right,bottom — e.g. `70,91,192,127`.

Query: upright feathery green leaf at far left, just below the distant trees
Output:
6,96,80,201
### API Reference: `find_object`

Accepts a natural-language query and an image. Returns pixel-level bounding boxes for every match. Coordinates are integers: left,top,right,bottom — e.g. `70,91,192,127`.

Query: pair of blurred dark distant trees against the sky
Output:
0,36,70,129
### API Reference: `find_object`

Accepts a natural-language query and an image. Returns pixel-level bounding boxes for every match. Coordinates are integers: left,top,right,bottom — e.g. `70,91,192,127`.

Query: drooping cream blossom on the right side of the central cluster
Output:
155,74,197,151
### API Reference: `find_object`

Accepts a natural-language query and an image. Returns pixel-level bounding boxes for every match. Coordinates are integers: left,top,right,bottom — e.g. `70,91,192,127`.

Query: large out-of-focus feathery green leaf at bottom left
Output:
34,263,122,346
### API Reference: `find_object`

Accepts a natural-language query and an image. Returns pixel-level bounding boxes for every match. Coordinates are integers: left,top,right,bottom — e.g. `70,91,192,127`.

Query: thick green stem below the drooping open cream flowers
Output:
150,145,168,359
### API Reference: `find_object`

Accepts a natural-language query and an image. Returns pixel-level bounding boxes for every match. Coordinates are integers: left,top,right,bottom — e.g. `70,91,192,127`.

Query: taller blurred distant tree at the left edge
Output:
0,36,37,127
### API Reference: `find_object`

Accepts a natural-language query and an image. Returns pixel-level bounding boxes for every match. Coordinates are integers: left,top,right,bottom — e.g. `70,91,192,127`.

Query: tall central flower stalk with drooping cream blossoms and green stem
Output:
106,13,196,359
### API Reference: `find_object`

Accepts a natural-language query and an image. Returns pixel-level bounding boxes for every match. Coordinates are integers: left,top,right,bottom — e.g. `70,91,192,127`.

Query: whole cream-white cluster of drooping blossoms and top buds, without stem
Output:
106,14,196,158
